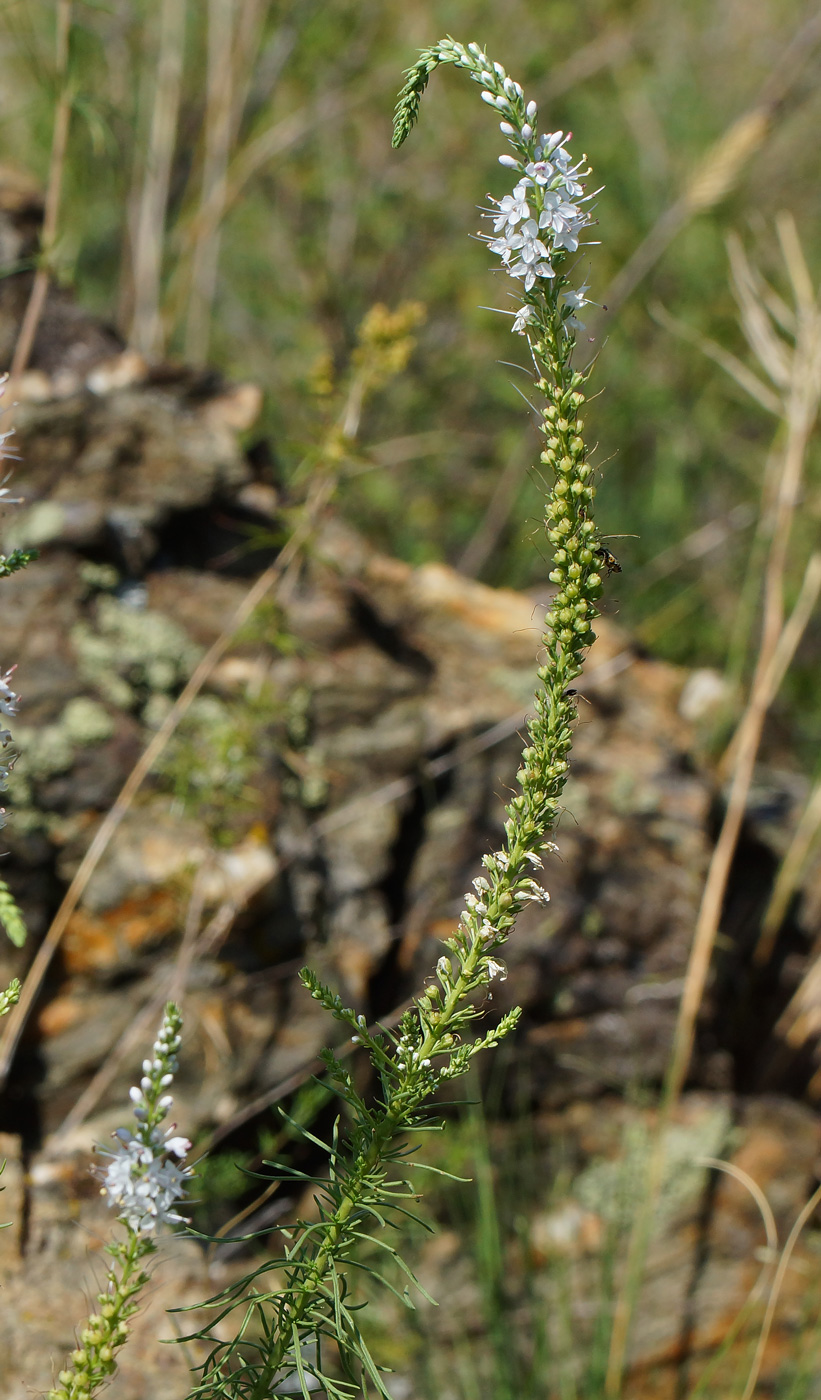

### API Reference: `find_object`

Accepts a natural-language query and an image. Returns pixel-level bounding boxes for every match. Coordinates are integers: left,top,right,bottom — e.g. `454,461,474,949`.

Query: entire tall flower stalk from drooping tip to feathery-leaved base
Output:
182,39,607,1400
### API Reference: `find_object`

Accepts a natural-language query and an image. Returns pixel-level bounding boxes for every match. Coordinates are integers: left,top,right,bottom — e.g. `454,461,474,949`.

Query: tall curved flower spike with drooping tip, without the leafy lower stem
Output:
394,39,601,996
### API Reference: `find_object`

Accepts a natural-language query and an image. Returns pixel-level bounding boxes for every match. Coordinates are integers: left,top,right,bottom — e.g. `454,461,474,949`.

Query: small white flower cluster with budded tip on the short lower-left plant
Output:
101,1007,193,1235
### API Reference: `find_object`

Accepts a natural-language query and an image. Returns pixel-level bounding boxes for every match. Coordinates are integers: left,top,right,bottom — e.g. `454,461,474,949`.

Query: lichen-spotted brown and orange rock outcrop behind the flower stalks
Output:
0,189,818,1400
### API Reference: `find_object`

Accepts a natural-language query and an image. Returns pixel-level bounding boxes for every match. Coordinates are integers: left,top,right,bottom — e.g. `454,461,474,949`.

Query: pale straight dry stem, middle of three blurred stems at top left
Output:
129,0,186,356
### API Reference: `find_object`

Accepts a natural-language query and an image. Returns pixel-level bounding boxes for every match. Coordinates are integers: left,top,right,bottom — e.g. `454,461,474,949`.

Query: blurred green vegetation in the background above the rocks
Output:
0,0,821,759
